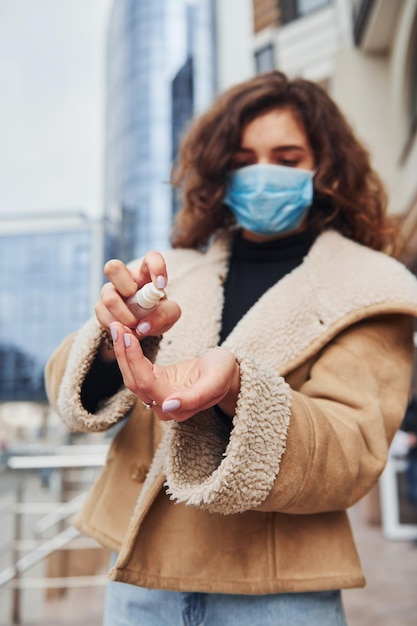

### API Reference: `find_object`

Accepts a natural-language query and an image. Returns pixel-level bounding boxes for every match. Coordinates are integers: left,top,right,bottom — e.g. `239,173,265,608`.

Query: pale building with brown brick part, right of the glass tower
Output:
218,0,417,274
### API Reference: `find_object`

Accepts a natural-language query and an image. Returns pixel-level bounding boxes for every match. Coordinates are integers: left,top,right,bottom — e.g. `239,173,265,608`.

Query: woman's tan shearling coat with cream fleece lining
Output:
46,231,417,594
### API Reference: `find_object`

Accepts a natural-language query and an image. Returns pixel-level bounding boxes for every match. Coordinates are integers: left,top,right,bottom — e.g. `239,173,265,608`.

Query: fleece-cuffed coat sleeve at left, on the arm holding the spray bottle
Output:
45,318,159,432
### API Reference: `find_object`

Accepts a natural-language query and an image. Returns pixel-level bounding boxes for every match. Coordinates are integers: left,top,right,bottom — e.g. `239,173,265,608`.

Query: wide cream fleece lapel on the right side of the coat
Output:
223,231,417,375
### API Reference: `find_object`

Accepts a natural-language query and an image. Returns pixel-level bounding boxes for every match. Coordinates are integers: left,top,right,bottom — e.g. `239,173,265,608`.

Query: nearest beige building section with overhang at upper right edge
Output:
333,0,417,275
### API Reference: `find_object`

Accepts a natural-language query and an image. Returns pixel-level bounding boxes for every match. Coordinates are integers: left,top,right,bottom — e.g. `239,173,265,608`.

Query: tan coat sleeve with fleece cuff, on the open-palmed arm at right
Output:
166,315,414,514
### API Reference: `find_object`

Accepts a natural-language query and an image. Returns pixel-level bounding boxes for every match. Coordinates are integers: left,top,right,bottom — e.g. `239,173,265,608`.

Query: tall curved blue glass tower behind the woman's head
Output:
105,0,216,260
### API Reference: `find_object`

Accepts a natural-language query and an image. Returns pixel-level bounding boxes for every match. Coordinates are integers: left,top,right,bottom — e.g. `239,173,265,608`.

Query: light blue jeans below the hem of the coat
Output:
103,560,347,626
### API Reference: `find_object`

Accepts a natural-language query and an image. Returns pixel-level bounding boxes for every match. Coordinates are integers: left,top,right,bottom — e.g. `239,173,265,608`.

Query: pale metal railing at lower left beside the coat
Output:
0,444,108,625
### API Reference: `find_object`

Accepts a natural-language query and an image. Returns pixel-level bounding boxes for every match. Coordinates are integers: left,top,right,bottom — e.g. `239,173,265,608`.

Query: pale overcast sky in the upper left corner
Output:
0,0,113,217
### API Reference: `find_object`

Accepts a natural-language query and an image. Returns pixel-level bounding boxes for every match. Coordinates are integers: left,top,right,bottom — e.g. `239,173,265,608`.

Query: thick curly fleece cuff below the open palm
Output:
165,346,291,514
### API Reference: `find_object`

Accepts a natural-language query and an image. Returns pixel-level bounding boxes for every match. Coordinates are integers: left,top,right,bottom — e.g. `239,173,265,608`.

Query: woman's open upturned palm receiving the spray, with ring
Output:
110,322,240,422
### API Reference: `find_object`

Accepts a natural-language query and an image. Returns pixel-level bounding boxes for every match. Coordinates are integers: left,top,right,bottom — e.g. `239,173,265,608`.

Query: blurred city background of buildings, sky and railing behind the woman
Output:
0,0,417,626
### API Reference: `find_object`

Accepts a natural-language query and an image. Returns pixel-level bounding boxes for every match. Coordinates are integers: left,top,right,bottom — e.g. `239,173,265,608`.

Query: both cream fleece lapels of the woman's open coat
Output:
157,231,417,374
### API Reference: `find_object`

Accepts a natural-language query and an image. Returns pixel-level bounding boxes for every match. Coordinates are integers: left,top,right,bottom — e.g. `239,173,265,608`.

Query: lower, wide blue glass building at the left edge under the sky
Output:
0,213,103,401
